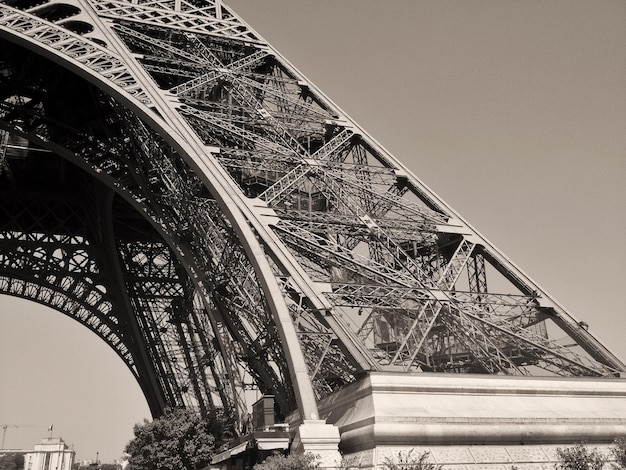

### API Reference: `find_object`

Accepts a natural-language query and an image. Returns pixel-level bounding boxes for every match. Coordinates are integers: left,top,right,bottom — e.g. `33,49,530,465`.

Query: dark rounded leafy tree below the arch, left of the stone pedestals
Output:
126,408,228,470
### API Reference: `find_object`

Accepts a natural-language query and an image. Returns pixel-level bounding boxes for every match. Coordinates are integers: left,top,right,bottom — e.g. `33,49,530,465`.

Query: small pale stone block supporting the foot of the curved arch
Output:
291,420,341,467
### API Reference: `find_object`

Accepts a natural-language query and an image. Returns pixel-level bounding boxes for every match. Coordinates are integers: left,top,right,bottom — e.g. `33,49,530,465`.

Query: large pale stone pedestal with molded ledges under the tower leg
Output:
319,372,626,470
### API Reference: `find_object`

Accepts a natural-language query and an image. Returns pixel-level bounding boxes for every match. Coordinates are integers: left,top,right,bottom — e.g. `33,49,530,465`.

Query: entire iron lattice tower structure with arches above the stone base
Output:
0,0,626,430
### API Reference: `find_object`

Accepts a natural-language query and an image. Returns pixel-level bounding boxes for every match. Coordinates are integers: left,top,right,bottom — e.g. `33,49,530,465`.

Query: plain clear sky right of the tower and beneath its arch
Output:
0,0,626,462
